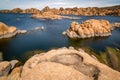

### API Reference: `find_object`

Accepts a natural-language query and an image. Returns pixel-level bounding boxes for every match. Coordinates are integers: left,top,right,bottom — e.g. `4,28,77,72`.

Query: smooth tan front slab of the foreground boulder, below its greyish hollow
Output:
22,62,91,80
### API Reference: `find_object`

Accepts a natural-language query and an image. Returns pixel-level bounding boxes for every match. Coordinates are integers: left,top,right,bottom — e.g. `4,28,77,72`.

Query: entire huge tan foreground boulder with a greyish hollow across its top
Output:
21,47,120,80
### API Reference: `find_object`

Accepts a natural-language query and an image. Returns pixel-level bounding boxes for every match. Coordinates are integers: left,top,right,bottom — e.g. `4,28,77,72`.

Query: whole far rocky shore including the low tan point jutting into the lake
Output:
0,5,120,20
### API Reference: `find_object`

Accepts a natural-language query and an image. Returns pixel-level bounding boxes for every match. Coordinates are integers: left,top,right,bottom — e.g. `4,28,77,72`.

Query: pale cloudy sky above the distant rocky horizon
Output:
0,0,120,9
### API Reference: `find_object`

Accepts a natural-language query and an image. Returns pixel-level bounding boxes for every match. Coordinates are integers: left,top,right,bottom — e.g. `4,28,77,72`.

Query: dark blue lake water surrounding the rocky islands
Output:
0,14,120,60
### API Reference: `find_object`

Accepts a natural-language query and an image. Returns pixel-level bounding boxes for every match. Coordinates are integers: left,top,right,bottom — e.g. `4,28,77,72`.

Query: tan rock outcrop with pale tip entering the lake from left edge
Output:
0,22,27,39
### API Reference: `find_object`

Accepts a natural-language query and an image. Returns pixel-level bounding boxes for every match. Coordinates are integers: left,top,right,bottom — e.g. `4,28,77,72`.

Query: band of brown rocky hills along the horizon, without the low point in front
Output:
0,5,120,16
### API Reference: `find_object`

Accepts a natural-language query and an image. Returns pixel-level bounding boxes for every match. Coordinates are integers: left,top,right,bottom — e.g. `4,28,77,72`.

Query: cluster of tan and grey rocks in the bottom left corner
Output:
0,60,22,80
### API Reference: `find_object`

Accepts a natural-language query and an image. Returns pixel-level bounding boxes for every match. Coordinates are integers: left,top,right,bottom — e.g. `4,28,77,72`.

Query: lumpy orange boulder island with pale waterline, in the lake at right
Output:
63,19,112,38
